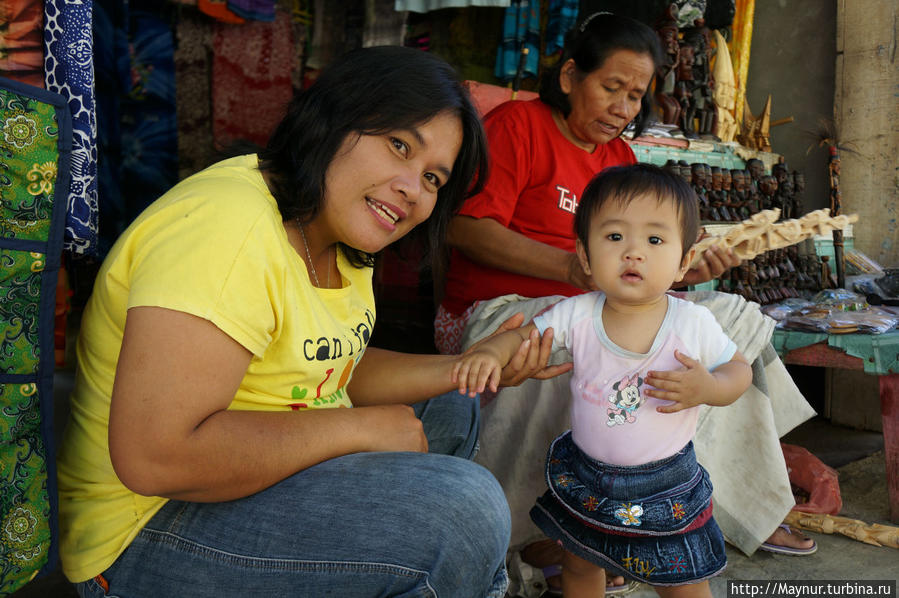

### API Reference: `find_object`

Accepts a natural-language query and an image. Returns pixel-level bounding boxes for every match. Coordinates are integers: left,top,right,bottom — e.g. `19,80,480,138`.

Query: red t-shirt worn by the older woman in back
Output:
443,99,637,315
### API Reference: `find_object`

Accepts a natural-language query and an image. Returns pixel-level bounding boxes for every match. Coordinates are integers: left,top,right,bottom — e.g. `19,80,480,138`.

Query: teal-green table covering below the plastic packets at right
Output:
771,329,899,375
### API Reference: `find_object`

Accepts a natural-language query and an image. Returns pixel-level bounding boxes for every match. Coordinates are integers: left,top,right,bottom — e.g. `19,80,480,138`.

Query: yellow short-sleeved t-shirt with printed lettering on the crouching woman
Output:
58,155,375,582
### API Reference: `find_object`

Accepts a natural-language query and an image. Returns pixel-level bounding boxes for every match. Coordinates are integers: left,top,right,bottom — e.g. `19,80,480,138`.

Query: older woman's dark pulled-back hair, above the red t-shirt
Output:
540,12,662,137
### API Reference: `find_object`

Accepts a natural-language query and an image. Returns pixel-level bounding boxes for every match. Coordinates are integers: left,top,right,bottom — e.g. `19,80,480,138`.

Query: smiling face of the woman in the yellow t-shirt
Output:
320,112,462,253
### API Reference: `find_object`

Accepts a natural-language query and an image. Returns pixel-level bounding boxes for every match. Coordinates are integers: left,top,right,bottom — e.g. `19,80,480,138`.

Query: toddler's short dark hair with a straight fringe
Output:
574,164,699,258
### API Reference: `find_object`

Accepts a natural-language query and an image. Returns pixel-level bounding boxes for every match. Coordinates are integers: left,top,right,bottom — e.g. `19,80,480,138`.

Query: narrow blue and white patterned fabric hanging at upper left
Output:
44,0,98,254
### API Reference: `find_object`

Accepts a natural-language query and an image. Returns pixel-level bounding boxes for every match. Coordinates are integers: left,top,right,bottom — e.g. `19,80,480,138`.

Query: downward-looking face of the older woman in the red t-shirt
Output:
559,50,654,151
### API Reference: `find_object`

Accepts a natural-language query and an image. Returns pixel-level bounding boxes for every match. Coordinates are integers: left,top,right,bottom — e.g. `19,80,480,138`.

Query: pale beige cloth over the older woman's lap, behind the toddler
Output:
462,291,815,554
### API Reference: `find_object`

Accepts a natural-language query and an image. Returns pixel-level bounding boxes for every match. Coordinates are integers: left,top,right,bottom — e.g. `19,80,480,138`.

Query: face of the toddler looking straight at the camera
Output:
577,195,692,306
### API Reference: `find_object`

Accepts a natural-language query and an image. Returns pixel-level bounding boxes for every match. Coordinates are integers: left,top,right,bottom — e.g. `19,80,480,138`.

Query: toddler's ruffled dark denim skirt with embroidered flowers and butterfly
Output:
531,431,727,586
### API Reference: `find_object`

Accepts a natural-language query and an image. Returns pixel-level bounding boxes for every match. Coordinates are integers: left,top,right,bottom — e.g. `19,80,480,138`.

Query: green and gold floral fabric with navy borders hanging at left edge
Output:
0,78,71,596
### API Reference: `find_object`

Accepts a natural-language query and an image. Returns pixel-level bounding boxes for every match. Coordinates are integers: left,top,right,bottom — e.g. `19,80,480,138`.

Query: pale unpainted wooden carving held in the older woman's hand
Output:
691,208,858,267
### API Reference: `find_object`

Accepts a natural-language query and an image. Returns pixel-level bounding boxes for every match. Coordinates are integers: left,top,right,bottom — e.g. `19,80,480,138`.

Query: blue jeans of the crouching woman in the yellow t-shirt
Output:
76,393,510,598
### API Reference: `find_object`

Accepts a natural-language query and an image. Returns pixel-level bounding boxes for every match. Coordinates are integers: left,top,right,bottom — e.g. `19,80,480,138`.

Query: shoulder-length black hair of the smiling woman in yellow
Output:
259,46,487,267
